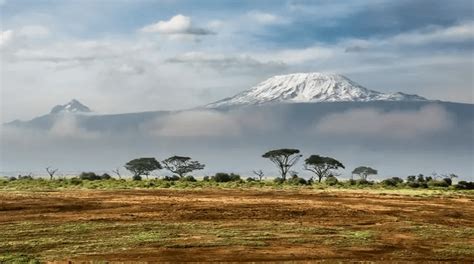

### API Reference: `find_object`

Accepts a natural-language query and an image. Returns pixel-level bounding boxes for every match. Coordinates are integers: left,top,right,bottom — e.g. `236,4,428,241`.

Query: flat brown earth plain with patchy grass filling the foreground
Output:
0,189,474,262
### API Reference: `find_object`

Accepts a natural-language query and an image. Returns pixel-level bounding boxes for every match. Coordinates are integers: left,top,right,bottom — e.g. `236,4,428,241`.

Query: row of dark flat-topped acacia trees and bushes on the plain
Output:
4,148,474,190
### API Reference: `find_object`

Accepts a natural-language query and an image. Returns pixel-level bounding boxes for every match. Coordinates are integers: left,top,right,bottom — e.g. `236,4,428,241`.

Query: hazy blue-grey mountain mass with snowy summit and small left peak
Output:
0,77,474,179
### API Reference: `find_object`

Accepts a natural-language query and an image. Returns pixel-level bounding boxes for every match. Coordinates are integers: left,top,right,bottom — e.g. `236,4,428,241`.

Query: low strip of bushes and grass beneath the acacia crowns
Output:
0,173,474,193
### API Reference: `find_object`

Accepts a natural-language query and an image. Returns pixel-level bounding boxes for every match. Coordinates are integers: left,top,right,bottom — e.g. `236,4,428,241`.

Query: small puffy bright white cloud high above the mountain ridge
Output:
141,14,213,35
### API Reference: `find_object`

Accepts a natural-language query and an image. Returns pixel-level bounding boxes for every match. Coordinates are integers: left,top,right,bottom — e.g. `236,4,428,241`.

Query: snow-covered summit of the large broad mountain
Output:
206,72,427,108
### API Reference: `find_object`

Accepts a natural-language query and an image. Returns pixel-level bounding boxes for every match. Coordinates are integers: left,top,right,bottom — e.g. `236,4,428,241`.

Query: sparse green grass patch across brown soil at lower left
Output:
0,221,384,263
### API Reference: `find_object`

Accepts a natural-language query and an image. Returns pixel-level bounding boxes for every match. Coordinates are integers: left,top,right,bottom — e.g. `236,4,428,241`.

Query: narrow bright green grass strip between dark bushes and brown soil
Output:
0,179,474,198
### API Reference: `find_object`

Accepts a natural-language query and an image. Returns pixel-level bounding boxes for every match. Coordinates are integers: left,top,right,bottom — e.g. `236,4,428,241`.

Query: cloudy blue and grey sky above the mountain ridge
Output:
0,0,474,122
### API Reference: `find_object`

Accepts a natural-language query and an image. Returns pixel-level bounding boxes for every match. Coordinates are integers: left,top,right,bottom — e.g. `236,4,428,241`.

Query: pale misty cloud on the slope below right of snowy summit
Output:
316,105,454,139
